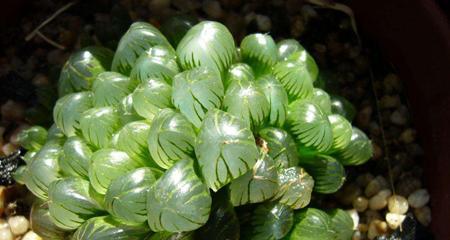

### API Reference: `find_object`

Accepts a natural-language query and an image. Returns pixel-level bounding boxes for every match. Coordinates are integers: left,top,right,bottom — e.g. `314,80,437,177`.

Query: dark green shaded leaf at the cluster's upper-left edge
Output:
58,46,113,97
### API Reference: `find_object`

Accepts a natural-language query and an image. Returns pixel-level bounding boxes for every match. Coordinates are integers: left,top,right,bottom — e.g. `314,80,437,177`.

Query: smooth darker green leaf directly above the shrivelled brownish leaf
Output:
259,127,298,169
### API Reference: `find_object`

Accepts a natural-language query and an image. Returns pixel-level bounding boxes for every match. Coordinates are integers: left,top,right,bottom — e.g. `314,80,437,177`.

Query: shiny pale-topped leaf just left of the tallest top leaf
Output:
130,46,179,84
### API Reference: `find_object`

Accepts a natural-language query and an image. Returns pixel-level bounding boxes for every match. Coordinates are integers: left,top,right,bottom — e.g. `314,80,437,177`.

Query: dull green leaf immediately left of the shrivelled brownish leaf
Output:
230,153,278,206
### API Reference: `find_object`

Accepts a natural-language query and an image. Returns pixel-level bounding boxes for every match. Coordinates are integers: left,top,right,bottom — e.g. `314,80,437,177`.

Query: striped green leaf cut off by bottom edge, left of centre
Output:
72,216,151,240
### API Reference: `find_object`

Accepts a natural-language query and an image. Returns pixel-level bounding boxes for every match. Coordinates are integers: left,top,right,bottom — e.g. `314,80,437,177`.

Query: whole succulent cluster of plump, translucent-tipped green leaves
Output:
16,21,372,240
